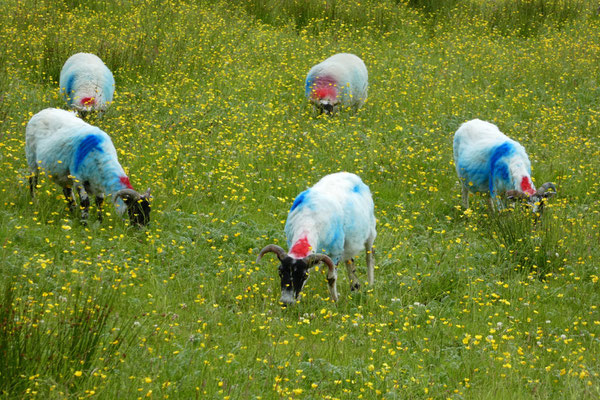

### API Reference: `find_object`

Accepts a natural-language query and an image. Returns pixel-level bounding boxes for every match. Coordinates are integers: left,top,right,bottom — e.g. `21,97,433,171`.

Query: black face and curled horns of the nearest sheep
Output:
256,244,335,305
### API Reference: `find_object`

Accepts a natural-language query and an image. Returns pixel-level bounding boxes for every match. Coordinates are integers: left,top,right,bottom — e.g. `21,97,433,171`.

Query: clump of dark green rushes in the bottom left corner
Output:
0,282,135,397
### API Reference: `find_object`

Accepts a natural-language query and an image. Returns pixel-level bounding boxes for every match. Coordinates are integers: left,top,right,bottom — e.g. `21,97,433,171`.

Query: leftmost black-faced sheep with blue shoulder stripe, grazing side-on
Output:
25,108,150,225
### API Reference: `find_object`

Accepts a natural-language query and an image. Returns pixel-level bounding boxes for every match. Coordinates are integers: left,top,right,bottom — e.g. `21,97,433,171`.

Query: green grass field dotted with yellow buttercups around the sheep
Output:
0,0,600,399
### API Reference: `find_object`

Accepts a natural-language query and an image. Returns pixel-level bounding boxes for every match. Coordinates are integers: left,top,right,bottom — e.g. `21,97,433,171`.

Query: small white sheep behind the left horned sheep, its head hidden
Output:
60,53,115,118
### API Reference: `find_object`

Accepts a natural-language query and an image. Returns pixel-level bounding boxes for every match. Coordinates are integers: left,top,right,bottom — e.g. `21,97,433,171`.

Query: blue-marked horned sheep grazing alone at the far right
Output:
454,119,556,211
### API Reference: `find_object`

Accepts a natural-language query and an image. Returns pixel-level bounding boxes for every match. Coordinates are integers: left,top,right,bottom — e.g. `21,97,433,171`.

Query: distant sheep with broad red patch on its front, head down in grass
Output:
305,53,369,114
